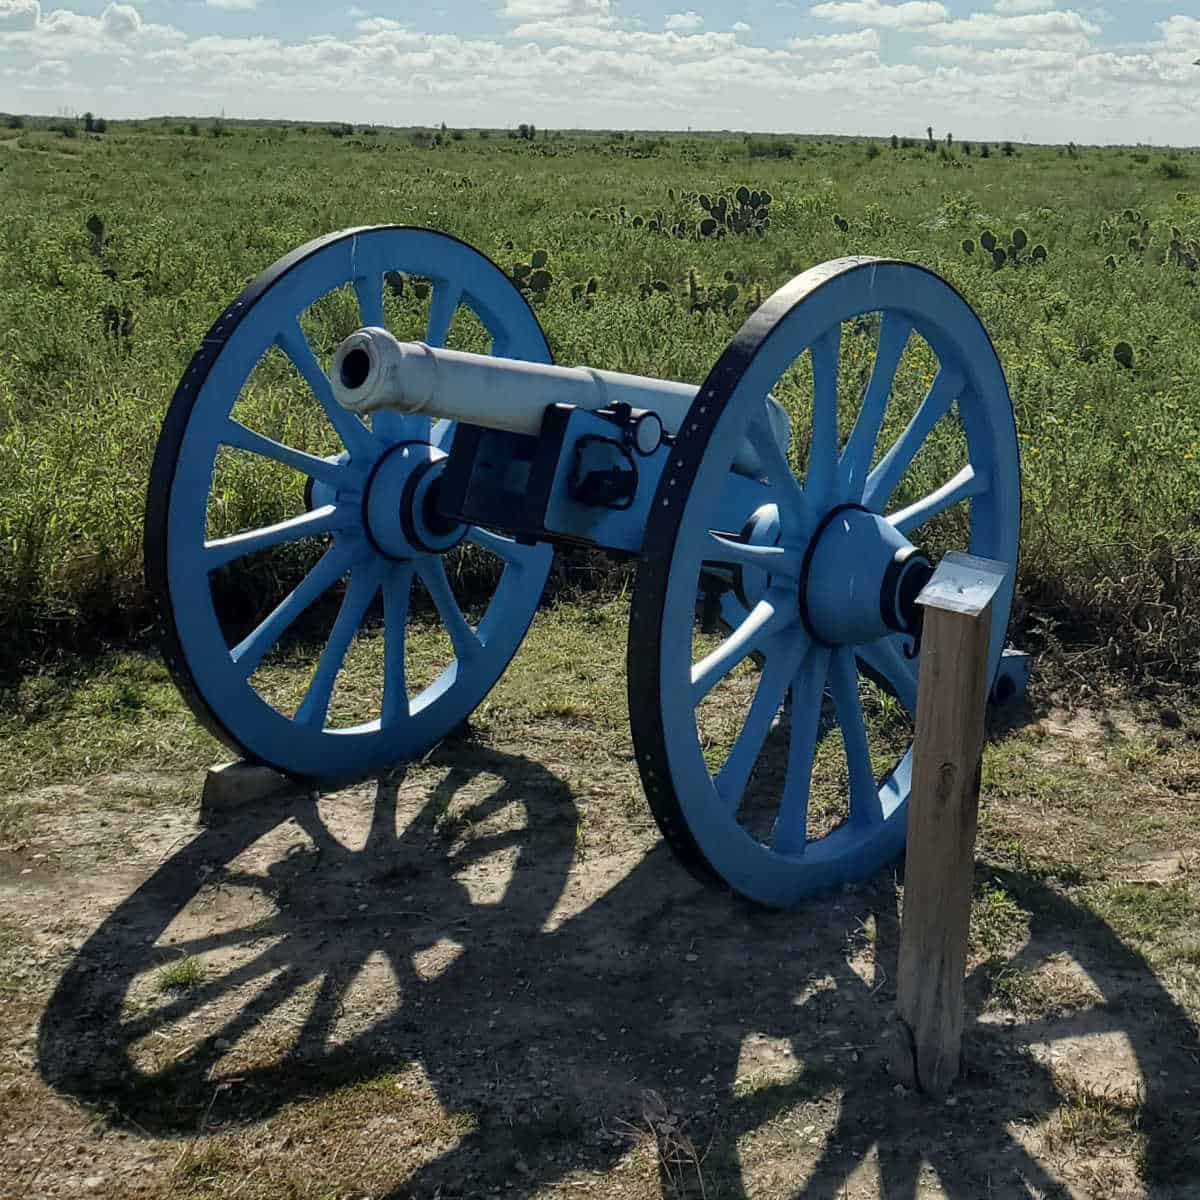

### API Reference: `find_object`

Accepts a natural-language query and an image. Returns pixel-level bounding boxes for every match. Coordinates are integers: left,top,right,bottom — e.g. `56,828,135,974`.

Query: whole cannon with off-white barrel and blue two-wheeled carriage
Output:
145,226,1020,906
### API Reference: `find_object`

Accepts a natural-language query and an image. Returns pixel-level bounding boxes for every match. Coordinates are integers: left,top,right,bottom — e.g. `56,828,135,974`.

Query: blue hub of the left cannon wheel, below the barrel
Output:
362,442,467,559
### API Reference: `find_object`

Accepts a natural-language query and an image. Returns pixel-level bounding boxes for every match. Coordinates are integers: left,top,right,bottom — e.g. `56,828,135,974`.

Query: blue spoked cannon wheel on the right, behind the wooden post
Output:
629,258,1020,906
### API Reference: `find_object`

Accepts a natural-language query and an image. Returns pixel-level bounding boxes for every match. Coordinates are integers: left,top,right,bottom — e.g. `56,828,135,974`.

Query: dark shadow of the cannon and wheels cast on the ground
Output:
38,744,1200,1200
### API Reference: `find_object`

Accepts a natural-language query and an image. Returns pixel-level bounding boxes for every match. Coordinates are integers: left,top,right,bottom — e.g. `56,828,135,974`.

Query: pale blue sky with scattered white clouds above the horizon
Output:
0,0,1200,145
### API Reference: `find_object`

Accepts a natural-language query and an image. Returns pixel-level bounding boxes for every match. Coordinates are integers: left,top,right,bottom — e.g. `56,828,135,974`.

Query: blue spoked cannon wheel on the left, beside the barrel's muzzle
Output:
145,227,552,781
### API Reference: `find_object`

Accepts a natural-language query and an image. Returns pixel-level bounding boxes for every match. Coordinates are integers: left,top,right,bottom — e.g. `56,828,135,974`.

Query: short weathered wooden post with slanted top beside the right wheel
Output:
892,554,1008,1096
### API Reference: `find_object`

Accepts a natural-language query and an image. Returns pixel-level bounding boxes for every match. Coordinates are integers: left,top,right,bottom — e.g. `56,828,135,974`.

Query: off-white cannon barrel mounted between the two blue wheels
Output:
330,328,791,475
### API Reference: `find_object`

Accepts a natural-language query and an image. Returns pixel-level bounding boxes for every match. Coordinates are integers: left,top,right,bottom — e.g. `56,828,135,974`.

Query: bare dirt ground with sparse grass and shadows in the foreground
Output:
0,657,1200,1200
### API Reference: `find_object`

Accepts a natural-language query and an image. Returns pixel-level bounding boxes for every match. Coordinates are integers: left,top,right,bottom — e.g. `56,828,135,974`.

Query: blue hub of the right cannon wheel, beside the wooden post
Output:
799,504,934,646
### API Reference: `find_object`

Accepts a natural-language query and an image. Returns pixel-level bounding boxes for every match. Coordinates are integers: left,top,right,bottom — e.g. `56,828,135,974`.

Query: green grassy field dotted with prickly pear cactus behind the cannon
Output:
0,122,1200,676
